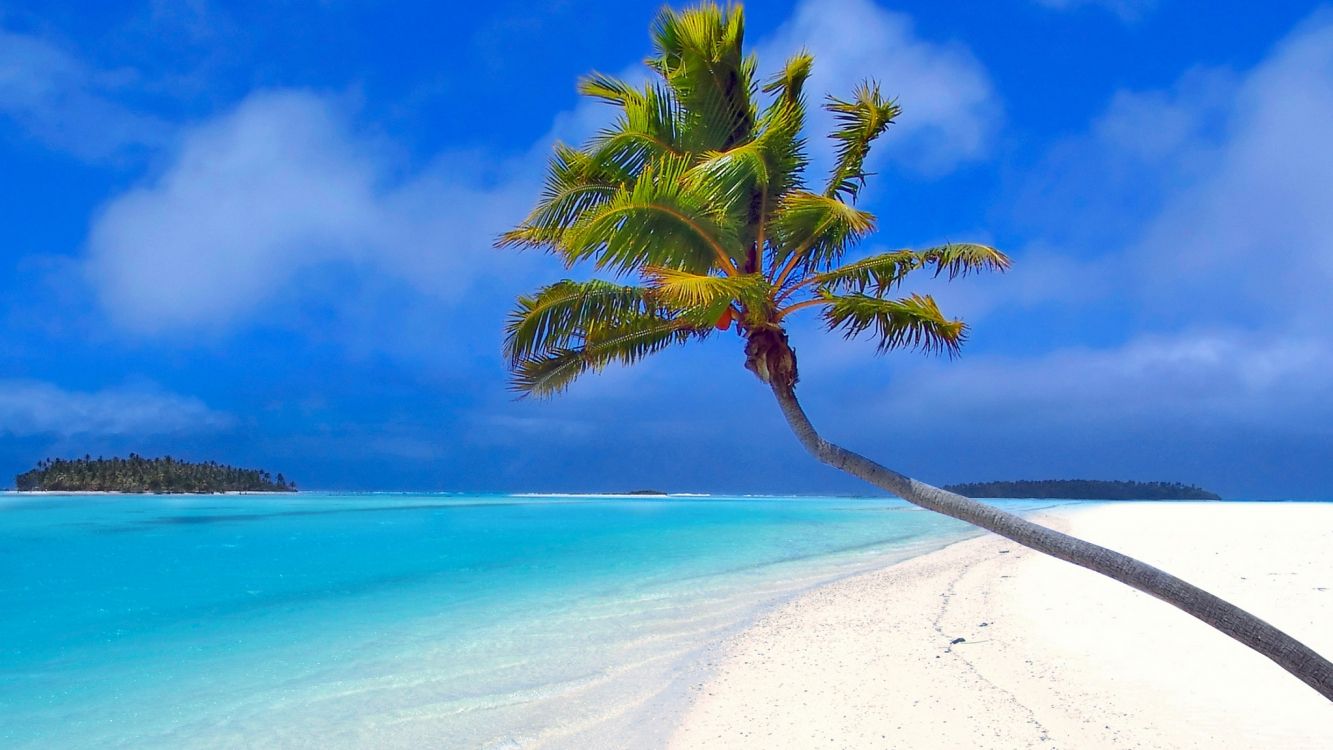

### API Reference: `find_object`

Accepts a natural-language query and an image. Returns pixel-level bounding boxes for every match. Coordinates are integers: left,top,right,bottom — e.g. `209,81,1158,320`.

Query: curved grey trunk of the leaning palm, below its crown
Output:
769,377,1333,701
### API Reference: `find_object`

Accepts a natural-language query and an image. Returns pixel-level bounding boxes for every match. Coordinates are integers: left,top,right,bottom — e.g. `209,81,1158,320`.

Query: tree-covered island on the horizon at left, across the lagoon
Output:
15,453,296,493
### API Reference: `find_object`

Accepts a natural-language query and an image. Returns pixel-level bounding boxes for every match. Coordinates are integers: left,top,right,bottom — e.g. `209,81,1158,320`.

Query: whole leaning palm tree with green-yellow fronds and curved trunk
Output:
497,4,1333,699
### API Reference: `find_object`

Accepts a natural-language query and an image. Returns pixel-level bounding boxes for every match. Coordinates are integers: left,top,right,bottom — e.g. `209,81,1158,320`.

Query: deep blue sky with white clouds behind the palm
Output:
0,0,1333,498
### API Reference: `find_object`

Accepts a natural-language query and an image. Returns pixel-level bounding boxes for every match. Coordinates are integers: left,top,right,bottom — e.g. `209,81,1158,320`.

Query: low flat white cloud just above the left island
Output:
0,380,233,437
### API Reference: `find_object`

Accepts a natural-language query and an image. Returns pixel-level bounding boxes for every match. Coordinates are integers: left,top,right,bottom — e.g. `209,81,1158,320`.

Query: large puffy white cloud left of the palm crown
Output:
87,91,532,333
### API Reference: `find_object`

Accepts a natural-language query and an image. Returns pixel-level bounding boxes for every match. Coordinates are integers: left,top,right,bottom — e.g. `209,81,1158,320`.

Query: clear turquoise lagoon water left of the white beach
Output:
0,493,1050,749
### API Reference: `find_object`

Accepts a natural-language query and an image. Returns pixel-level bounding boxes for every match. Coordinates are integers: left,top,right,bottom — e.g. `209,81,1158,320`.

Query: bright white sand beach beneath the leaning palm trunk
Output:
670,504,1333,750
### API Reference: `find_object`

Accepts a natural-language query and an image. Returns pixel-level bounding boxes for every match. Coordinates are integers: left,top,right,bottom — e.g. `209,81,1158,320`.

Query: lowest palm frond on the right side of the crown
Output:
824,293,968,357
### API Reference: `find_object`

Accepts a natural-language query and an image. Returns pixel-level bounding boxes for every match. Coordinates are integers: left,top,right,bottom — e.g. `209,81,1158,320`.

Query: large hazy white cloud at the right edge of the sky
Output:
986,13,1333,333
